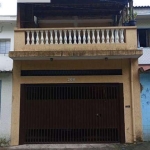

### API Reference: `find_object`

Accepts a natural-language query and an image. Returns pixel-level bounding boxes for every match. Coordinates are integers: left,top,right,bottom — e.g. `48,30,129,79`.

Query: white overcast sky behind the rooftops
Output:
0,0,150,15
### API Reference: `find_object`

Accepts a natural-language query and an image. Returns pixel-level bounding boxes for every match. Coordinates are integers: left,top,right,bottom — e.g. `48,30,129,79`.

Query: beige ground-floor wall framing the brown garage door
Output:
11,59,142,145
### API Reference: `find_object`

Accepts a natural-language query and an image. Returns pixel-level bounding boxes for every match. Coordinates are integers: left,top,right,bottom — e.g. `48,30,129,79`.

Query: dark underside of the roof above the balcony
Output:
18,0,128,22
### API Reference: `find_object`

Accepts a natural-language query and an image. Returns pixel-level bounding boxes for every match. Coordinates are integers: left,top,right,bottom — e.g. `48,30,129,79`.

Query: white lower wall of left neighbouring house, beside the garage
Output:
0,73,12,140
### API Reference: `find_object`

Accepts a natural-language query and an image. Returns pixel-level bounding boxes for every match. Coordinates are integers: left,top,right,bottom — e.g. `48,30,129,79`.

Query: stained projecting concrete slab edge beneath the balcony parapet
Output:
9,50,143,60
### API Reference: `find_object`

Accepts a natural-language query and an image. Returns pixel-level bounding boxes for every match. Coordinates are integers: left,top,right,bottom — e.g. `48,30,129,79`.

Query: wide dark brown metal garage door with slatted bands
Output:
20,84,124,144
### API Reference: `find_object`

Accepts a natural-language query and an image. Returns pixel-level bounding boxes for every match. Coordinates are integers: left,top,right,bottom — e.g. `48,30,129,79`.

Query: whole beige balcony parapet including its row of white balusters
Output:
15,26,137,51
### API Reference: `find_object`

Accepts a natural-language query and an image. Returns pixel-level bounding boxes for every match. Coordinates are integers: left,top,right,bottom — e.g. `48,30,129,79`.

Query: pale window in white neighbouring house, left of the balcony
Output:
0,39,10,54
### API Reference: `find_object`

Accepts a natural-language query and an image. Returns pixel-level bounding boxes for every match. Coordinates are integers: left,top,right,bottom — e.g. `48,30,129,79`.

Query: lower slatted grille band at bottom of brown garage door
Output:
25,128,119,143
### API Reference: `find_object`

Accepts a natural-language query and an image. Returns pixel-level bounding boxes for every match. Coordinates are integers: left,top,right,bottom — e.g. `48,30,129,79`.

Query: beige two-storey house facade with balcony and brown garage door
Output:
9,0,142,145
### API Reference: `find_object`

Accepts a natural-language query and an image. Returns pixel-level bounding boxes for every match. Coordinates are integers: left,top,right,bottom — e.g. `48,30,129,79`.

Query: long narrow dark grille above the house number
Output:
21,69,122,76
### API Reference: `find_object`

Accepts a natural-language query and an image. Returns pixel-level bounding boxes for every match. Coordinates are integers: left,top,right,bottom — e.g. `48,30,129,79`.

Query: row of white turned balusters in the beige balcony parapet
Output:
25,27,126,45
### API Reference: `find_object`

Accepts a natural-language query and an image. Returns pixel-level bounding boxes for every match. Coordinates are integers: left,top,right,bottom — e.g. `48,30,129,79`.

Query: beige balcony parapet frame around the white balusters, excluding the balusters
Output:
14,25,137,51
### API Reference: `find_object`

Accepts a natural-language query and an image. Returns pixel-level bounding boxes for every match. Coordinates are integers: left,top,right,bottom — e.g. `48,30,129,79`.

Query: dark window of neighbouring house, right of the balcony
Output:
138,29,150,47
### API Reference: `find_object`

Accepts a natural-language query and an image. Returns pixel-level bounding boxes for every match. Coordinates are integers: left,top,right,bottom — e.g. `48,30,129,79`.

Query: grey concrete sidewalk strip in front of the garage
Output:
0,142,150,150
